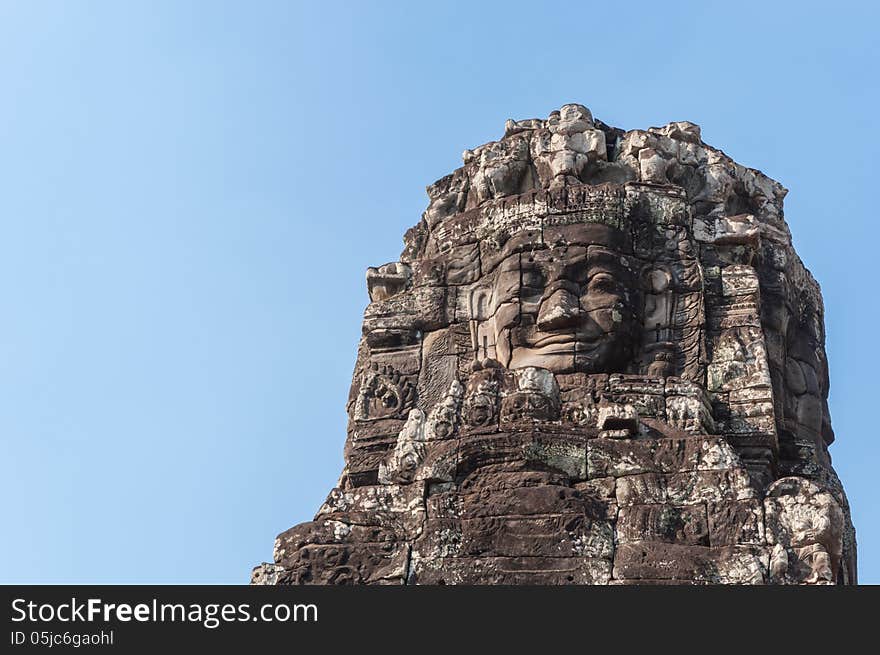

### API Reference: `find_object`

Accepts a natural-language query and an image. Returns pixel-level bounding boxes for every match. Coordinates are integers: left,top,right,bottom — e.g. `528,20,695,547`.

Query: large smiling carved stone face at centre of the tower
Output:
471,229,635,373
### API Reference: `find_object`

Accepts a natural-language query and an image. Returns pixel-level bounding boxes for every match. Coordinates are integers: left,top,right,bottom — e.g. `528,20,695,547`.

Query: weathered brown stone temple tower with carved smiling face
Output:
252,104,856,584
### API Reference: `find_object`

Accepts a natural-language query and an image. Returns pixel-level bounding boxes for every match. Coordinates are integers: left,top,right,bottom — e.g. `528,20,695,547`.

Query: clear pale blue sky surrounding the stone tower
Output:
0,0,880,583
